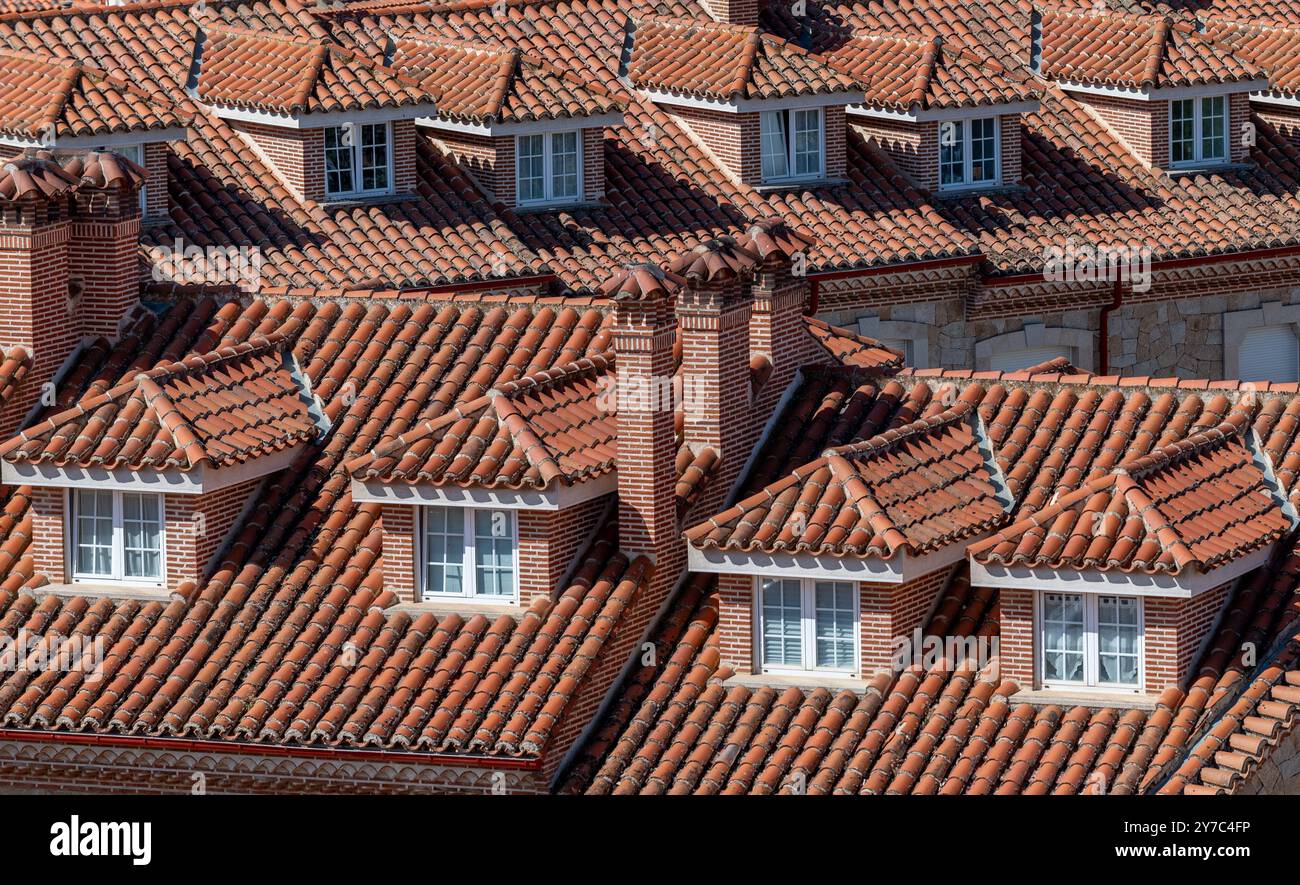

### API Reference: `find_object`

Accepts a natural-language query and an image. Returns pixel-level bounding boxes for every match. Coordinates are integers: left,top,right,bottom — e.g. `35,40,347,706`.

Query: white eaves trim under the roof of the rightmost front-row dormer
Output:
971,545,1275,599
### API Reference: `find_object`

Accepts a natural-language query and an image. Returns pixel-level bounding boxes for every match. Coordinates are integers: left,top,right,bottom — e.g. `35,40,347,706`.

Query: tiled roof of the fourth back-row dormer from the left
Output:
628,16,858,100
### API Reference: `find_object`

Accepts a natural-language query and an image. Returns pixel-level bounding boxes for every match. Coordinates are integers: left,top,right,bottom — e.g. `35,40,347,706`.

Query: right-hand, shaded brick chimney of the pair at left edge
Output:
64,152,148,340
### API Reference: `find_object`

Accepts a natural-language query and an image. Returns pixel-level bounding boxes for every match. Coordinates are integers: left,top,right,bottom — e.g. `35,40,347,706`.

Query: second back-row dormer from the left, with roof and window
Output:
192,25,437,201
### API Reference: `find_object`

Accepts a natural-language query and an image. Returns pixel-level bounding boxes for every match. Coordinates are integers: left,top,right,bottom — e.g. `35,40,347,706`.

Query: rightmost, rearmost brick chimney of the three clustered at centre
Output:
740,218,816,416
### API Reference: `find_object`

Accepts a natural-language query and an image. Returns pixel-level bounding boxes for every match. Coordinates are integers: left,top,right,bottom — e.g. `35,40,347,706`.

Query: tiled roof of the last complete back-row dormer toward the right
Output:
1041,6,1264,87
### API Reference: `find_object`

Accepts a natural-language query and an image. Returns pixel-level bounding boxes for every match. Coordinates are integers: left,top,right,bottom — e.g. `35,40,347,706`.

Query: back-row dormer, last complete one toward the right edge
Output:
1031,8,1268,169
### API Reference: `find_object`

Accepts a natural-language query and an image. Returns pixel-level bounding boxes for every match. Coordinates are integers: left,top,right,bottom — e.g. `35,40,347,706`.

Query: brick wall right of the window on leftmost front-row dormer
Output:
163,480,260,590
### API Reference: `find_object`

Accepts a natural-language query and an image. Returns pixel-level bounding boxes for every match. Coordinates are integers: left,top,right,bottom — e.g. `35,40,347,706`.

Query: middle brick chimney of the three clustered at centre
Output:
668,237,761,513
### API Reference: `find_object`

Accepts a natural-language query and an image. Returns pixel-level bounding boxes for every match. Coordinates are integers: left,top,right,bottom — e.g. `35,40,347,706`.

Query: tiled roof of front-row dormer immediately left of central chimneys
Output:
347,352,618,489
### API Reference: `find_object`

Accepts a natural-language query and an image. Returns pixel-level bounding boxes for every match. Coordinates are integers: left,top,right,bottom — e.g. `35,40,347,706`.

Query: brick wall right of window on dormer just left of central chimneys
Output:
517,495,608,606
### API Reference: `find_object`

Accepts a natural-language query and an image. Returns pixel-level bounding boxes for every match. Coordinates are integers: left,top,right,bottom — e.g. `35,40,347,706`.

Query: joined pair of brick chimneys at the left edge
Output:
0,151,143,439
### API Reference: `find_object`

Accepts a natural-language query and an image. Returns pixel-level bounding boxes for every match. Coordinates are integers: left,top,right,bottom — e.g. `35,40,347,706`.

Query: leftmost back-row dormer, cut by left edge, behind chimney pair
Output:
0,49,190,221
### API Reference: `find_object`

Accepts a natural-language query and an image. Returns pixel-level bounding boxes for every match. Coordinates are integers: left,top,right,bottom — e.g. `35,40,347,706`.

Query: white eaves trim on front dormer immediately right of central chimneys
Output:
686,538,978,584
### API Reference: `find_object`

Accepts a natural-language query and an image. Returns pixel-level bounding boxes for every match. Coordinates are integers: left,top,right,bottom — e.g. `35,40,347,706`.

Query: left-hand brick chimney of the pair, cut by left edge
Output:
0,155,78,438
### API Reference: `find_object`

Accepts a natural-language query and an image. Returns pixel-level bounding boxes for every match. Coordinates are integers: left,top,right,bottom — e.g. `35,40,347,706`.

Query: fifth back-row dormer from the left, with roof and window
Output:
824,34,1040,191
